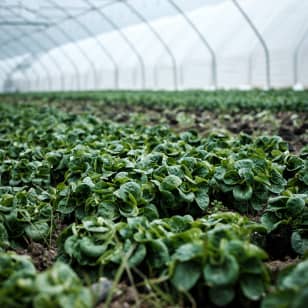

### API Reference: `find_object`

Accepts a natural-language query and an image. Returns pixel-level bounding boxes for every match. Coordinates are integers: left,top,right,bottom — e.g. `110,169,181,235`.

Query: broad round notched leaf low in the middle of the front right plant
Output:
203,255,239,287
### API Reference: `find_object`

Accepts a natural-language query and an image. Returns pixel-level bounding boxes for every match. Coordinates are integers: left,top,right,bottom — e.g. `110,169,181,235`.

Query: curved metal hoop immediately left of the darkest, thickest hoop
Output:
168,0,217,89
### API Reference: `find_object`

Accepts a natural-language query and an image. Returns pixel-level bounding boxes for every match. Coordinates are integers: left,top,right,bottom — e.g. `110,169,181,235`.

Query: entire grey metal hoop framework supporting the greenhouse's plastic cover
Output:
0,0,308,91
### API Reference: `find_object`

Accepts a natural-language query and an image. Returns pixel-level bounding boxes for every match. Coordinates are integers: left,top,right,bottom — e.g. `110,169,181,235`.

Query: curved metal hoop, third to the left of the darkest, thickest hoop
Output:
86,0,146,89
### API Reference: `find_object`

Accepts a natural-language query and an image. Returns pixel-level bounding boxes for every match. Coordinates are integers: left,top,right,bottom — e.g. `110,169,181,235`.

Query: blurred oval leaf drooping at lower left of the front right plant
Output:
171,261,201,291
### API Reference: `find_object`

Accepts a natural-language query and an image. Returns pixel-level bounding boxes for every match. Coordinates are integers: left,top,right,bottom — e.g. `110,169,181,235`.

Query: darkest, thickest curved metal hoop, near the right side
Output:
232,0,271,89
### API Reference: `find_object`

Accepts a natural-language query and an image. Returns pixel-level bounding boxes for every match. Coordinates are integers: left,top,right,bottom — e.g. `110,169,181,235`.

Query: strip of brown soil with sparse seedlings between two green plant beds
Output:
41,100,308,152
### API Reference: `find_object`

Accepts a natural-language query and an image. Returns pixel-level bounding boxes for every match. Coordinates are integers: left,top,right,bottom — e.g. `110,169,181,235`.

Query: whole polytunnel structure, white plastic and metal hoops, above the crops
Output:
0,0,308,92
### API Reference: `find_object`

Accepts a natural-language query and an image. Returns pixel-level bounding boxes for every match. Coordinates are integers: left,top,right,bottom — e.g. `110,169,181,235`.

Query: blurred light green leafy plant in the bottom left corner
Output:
0,253,94,308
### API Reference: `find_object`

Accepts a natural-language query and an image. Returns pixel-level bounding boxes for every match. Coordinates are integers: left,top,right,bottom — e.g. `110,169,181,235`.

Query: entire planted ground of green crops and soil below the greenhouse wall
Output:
0,90,308,308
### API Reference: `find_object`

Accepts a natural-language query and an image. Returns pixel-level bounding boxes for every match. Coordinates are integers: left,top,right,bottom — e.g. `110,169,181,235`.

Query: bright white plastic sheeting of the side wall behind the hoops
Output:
0,0,308,91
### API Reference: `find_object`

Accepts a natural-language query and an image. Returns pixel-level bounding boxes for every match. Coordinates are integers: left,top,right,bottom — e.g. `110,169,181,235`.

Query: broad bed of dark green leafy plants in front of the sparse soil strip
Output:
0,104,308,307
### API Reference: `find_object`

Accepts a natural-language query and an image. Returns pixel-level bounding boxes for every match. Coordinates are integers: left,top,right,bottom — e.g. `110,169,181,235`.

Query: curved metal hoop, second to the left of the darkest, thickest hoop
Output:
119,0,178,90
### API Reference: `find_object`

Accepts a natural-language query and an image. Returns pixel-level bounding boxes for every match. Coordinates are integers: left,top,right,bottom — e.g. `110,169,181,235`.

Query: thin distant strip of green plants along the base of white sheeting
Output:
2,89,308,111
